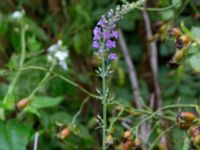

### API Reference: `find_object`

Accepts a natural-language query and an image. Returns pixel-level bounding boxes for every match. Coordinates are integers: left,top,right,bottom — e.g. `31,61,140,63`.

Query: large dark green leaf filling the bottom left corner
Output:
0,120,30,150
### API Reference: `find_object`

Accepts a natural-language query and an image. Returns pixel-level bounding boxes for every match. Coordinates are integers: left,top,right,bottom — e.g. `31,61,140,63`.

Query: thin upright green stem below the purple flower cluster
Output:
102,54,107,150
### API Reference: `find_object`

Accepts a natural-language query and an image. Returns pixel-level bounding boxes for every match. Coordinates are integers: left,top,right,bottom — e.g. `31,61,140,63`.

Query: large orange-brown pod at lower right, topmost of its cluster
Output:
176,112,196,130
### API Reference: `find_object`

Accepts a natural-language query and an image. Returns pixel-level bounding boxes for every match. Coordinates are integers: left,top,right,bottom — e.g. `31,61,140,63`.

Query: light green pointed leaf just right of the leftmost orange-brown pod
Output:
31,96,63,108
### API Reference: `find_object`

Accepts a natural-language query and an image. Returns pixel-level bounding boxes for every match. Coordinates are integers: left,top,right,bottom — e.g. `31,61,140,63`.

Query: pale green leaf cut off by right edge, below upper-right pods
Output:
189,53,200,72
